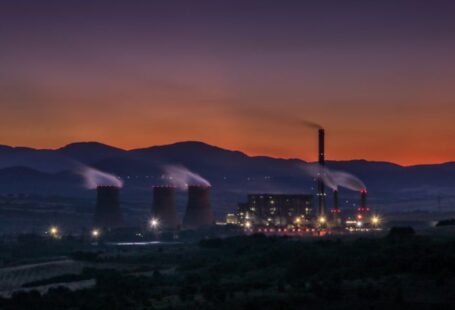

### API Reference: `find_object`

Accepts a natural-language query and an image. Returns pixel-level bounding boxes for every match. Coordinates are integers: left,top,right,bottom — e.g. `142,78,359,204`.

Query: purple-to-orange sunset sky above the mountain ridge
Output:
0,1,455,165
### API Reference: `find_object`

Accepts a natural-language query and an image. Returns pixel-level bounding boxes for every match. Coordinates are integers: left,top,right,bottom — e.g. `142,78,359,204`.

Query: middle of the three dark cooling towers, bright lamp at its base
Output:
152,186,180,230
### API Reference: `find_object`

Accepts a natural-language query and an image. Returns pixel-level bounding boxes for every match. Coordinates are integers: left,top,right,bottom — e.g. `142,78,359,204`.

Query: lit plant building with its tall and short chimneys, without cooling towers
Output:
226,124,381,233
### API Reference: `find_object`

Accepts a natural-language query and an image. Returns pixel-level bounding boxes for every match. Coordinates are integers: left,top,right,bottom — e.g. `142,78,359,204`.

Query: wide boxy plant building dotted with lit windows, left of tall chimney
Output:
237,194,313,228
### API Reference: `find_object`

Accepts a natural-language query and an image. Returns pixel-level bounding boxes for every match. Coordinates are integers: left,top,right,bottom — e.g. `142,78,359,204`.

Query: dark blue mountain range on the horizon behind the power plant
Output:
0,141,455,212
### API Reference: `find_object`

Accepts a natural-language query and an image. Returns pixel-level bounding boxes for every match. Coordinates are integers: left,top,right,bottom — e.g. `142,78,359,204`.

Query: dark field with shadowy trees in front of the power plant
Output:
0,231,455,310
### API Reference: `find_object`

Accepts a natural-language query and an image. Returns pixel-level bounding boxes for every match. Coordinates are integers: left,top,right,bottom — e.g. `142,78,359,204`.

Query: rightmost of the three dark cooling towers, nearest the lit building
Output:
183,185,214,229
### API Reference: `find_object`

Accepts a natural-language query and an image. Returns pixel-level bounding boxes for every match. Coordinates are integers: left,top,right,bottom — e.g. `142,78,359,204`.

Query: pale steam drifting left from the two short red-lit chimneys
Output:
302,164,366,191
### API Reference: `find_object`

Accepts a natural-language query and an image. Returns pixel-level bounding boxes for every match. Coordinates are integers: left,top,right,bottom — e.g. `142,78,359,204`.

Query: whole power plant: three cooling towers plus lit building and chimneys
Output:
87,124,380,233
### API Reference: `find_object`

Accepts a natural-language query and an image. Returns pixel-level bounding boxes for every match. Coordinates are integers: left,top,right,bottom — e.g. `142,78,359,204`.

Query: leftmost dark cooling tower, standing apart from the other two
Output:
95,186,123,229
